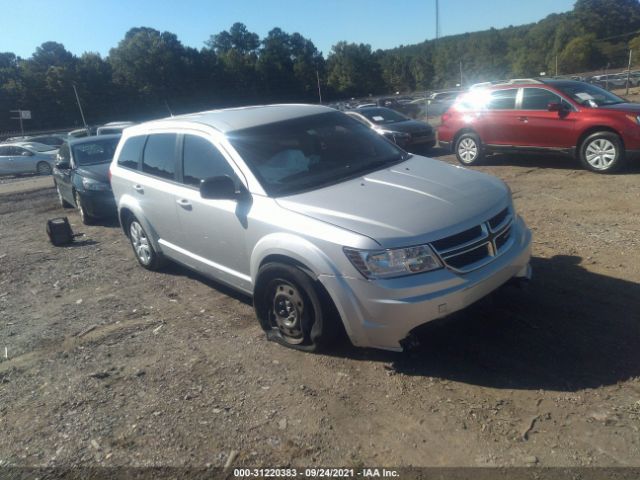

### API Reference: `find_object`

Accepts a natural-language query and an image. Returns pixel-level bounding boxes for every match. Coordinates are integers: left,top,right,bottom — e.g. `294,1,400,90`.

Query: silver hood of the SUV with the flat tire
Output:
277,156,510,248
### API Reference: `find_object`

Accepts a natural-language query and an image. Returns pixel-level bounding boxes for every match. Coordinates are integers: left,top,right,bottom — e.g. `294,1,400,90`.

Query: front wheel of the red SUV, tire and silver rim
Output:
579,131,625,173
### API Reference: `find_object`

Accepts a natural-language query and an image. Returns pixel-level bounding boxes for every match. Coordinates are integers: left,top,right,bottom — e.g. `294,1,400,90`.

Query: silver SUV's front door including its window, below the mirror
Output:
175,132,251,290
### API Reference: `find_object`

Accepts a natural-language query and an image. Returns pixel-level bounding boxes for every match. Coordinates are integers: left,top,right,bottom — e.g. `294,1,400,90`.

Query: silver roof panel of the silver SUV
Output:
127,104,335,134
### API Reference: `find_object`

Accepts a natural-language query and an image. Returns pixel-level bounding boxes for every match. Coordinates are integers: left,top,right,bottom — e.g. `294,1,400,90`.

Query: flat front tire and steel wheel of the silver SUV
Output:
253,263,339,352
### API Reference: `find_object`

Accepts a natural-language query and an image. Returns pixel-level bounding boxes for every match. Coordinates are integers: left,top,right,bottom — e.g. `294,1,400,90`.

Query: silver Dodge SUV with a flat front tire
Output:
110,105,531,351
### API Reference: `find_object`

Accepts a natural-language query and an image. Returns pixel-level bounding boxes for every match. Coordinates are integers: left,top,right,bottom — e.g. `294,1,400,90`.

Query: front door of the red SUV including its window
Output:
514,87,576,148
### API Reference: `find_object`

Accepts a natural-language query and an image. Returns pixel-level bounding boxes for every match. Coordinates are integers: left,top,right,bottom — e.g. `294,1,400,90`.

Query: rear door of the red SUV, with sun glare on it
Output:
476,88,519,145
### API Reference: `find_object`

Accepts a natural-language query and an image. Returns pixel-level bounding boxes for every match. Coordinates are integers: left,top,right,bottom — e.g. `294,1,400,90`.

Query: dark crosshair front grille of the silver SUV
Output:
431,208,513,273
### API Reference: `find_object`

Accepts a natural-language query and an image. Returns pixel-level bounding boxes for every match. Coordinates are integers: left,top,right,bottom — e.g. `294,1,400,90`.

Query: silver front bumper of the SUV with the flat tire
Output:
319,217,531,351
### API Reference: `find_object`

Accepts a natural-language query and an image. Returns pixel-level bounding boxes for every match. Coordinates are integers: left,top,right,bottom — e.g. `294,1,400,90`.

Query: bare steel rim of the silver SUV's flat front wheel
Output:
271,280,305,345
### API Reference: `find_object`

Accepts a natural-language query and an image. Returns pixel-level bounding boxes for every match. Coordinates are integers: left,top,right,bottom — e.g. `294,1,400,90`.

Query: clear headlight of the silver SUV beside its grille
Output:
344,245,442,279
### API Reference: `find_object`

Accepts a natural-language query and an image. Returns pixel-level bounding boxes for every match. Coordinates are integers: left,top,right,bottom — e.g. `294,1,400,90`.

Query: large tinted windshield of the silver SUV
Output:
227,112,409,197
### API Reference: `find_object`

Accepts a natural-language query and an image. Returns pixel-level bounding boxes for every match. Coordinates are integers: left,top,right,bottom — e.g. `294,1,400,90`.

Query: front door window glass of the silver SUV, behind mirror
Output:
182,135,235,187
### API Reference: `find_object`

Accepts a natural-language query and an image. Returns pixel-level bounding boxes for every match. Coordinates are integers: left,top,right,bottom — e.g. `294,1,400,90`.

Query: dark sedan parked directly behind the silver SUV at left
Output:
53,134,120,225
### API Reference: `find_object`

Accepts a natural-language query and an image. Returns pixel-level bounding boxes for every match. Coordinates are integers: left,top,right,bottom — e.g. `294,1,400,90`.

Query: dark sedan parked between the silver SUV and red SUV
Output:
345,107,436,149
